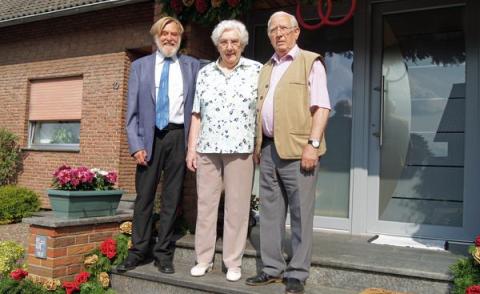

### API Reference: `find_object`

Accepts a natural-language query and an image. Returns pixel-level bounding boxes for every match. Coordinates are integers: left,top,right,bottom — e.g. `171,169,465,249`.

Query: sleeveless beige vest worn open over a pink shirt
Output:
255,50,327,159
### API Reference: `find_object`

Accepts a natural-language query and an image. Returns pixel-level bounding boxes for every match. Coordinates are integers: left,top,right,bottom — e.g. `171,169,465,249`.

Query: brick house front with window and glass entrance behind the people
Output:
0,0,480,241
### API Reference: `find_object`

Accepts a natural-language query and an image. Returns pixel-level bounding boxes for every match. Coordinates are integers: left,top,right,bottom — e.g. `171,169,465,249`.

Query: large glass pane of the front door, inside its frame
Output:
379,7,465,226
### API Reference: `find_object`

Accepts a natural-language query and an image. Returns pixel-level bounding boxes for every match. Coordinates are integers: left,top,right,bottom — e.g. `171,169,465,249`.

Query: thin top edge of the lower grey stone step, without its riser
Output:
112,264,358,294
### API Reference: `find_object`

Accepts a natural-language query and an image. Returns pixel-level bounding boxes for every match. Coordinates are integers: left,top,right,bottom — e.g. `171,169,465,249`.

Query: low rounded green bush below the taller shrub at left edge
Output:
0,185,40,224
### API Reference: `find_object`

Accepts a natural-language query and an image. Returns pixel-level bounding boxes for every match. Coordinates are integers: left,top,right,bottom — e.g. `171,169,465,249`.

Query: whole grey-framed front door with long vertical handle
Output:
367,0,480,240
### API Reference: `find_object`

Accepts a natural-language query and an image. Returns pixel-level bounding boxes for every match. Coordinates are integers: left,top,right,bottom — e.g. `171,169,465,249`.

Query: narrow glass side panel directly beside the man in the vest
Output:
299,16,353,218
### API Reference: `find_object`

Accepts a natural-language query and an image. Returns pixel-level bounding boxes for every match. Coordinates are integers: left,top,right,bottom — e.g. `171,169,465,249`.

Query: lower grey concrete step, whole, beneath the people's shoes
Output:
111,263,358,294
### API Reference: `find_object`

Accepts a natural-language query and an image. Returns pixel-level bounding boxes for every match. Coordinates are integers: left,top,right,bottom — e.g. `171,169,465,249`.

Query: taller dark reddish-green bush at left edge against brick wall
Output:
0,128,21,186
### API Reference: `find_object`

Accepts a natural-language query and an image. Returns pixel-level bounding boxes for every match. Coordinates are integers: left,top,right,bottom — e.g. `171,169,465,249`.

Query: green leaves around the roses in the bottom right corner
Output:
450,246,480,294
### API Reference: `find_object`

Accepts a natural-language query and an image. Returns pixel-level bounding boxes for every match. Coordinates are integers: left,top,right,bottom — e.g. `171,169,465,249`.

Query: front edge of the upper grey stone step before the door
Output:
176,240,453,283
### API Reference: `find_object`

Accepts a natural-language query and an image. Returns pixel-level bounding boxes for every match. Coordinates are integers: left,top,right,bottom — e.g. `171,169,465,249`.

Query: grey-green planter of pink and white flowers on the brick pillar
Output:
47,165,123,218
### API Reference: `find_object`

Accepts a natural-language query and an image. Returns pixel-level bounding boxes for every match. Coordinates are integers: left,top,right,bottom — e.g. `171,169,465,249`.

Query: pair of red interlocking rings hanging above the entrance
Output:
296,0,357,30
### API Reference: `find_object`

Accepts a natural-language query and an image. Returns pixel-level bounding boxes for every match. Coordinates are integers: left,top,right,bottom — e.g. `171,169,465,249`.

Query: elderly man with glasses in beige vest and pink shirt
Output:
247,11,330,293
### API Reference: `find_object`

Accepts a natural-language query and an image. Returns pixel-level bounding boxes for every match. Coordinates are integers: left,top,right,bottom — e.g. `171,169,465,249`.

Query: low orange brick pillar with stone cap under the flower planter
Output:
23,212,132,281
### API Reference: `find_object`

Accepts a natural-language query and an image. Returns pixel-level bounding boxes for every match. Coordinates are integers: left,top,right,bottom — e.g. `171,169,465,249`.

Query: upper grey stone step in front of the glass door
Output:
174,228,460,294
